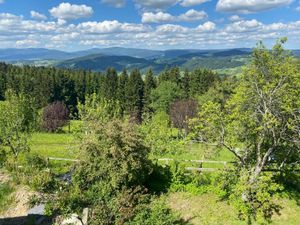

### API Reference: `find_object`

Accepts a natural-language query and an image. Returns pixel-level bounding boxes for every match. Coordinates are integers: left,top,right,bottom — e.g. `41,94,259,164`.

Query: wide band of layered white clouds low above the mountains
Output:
0,13,300,50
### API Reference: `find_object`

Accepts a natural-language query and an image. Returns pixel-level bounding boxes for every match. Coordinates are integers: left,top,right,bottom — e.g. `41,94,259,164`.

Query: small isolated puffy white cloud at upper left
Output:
49,2,93,20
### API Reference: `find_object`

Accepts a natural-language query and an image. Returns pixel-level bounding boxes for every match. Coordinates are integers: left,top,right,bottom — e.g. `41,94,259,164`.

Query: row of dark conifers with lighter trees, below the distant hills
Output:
0,63,219,119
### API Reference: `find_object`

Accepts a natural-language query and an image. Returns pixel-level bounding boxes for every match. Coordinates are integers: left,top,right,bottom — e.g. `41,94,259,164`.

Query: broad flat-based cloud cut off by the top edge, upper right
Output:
216,0,293,13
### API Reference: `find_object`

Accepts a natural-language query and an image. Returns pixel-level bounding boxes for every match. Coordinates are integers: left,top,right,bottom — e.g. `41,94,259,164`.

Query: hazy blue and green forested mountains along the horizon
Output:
0,47,300,72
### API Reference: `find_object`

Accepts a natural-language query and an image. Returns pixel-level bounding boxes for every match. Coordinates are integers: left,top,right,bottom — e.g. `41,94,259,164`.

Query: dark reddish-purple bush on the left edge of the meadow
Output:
42,102,69,132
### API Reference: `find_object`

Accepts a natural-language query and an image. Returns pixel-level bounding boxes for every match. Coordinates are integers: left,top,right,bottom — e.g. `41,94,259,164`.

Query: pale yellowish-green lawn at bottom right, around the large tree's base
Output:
168,193,300,225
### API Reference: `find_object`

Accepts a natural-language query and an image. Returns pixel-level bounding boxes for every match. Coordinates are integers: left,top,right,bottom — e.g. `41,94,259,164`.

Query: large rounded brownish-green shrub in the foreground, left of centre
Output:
52,120,157,224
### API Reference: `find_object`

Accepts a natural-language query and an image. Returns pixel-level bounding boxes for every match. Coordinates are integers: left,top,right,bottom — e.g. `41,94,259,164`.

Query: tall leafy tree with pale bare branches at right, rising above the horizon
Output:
190,39,300,222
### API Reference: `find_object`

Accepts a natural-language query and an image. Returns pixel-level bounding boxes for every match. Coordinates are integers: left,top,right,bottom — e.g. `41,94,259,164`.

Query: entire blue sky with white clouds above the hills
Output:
0,0,300,51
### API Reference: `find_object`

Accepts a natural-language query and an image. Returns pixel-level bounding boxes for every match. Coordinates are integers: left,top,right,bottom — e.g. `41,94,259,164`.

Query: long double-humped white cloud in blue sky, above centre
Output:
142,9,208,23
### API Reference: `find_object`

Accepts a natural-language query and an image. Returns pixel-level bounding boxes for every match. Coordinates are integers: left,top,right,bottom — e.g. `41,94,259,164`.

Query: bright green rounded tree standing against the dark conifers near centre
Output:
151,81,183,112
